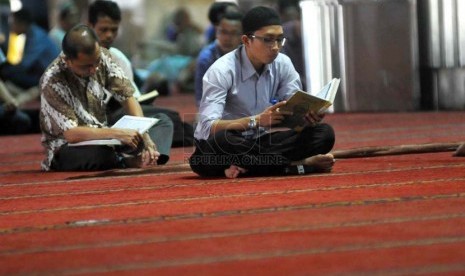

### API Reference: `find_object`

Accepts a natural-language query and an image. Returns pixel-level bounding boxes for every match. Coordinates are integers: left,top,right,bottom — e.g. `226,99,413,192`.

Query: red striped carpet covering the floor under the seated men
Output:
0,104,465,275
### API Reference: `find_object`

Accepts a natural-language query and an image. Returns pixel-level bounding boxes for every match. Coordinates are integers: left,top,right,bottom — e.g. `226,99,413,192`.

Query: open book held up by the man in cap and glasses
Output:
279,78,341,131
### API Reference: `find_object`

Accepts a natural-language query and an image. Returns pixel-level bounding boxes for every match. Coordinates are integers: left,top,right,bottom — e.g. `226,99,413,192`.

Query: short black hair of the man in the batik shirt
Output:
61,24,99,59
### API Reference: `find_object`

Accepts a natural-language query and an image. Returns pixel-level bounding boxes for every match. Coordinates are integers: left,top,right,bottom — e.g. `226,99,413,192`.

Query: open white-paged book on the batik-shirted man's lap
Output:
68,115,159,146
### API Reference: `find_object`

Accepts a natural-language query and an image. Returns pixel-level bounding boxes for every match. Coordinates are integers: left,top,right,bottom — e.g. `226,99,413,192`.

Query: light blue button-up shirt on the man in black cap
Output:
194,46,302,140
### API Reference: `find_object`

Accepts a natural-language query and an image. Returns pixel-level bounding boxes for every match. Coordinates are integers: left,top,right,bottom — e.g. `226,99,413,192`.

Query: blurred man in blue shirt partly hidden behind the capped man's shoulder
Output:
195,8,242,108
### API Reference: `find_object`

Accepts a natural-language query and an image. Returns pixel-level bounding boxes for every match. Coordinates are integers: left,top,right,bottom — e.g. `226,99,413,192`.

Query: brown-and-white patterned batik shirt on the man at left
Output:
40,47,134,171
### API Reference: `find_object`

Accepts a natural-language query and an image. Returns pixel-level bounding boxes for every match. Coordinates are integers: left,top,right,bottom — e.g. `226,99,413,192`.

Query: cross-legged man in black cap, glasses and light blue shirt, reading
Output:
189,7,334,178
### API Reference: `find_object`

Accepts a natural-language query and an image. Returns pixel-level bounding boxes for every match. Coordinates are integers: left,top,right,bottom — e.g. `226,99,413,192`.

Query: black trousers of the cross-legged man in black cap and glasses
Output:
189,124,335,176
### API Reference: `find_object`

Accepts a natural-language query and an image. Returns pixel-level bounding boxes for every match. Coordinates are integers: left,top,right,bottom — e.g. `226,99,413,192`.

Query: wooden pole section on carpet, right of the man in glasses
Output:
331,142,464,159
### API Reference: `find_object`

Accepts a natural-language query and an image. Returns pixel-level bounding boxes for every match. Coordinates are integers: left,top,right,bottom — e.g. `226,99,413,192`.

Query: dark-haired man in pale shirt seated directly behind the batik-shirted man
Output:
88,0,193,146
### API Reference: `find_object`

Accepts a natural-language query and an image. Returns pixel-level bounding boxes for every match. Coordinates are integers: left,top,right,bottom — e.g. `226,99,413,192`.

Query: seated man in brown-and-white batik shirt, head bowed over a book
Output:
40,25,173,171
